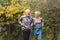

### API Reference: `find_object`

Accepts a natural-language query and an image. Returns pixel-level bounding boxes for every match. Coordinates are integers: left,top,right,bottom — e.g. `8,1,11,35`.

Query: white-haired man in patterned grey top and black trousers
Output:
18,9,34,40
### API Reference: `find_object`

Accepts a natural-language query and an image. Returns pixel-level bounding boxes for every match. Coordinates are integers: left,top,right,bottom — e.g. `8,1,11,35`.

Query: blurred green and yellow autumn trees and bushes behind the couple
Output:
0,0,60,40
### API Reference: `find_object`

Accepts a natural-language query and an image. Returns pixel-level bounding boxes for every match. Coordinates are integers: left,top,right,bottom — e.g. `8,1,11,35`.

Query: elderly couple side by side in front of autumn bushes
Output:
18,9,44,40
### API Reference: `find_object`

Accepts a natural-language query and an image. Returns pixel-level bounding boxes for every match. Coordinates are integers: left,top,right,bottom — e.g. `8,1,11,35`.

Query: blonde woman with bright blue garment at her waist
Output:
34,11,44,40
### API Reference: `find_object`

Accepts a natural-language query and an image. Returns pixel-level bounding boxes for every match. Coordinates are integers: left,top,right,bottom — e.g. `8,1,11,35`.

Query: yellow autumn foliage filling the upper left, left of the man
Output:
0,0,30,24
